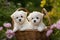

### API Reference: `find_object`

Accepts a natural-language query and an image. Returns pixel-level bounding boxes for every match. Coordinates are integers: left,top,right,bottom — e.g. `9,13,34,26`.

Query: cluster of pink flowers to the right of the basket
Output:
46,20,60,37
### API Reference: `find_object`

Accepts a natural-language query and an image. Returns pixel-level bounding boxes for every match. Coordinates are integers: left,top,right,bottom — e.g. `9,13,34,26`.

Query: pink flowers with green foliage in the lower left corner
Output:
0,23,15,40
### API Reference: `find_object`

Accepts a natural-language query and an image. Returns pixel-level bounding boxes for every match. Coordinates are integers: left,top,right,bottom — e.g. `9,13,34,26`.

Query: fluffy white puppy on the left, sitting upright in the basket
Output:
11,10,29,32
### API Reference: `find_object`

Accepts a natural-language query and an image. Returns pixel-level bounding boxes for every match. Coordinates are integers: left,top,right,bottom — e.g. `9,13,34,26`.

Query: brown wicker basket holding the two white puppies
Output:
11,8,50,40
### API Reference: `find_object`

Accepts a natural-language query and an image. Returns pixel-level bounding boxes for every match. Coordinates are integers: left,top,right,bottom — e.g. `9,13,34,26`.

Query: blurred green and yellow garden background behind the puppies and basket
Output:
0,0,60,40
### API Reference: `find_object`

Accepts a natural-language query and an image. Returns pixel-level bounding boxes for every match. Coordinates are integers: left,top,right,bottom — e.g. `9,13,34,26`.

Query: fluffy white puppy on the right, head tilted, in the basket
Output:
28,11,47,32
